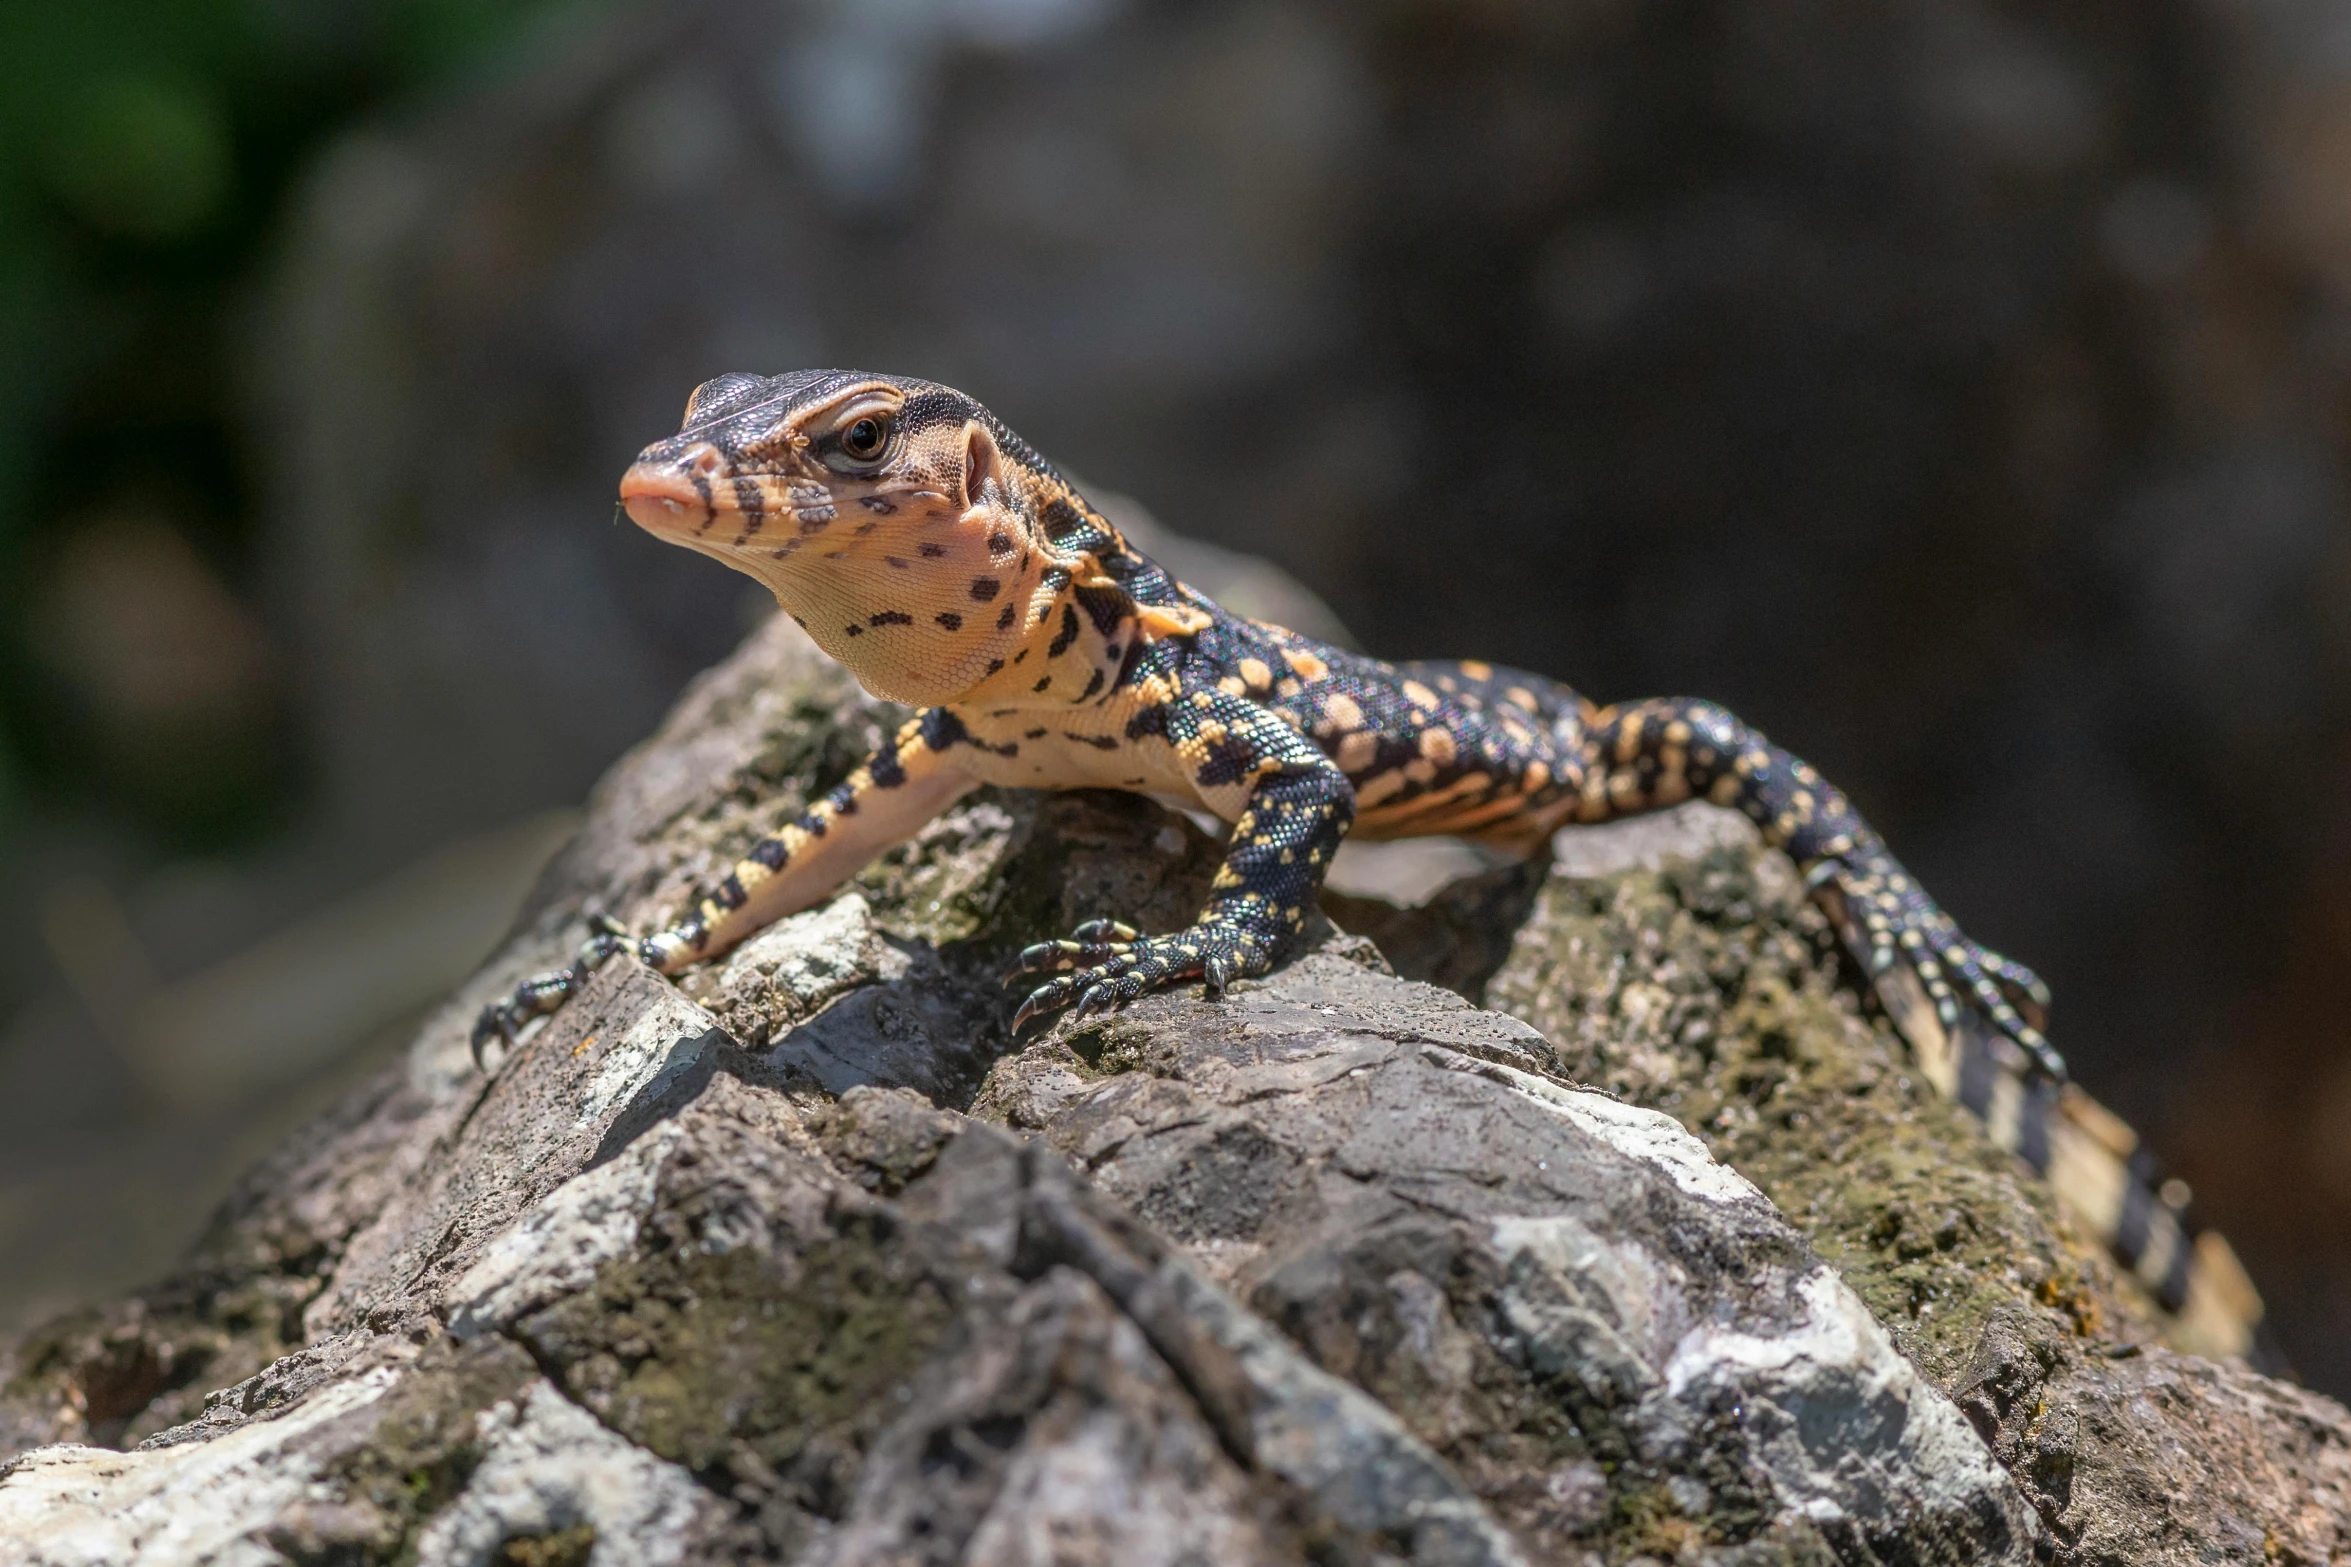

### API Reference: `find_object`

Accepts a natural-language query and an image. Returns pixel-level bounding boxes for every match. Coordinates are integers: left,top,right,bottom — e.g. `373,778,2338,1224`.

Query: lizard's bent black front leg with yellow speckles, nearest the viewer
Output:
1006,747,1354,1029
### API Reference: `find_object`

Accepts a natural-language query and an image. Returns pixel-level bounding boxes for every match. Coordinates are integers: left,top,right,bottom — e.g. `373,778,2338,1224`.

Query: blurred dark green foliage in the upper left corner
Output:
0,0,576,853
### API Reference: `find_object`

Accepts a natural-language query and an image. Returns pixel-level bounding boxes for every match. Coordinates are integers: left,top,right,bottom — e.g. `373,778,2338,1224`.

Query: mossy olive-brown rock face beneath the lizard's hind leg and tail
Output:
1486,848,2149,1386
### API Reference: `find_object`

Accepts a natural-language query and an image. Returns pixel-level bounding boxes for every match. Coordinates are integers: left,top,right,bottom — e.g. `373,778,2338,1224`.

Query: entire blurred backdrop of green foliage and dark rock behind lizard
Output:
0,0,2351,1395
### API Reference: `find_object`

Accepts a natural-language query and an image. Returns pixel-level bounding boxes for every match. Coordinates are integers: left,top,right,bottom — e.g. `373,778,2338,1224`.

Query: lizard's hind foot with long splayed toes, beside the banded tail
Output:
1806,848,2064,1083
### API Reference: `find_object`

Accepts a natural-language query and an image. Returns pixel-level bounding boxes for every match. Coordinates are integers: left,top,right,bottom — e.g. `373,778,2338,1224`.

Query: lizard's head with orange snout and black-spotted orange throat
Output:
621,371,1072,705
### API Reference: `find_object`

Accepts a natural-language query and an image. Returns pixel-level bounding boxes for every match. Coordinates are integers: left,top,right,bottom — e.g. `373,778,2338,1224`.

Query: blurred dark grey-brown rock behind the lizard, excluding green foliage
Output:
0,0,2351,1393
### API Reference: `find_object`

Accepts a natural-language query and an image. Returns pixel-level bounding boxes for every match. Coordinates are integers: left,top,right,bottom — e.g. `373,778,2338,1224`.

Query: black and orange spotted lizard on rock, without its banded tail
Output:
473,371,2064,1078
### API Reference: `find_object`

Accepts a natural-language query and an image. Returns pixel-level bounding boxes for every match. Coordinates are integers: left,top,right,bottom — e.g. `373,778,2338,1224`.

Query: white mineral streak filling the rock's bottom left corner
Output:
0,1367,395,1567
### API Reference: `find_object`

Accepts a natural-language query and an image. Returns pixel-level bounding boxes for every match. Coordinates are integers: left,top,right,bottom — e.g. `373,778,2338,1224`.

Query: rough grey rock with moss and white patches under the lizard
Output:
0,620,2351,1567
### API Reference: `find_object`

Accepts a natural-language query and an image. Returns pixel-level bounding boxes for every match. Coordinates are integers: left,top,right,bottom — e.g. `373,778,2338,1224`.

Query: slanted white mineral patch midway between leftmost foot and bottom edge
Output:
442,1121,682,1339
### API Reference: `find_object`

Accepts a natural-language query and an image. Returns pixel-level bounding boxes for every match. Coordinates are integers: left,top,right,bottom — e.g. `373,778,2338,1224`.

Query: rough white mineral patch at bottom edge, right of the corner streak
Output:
416,1381,701,1567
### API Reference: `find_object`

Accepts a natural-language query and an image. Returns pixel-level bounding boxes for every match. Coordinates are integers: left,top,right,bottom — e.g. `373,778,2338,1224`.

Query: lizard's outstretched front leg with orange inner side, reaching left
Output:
473,707,978,1064
